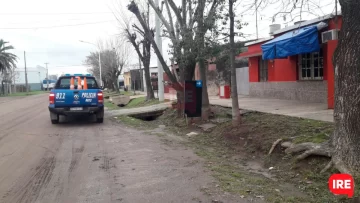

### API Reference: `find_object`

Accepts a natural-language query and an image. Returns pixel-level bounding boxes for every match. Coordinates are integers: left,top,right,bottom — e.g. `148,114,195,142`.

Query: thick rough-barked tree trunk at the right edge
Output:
332,0,360,175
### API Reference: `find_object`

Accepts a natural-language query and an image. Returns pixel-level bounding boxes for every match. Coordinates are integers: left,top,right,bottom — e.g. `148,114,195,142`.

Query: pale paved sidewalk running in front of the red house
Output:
165,94,334,122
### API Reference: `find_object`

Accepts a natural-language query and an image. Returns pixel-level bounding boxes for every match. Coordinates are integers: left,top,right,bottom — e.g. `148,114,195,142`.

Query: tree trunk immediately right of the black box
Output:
196,0,210,120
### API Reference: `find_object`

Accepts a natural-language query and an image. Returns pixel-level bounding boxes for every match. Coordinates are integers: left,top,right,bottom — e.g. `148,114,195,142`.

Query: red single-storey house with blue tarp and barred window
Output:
238,12,342,108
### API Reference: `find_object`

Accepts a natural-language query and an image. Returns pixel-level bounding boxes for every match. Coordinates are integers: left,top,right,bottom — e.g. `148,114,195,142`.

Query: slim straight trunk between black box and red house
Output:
229,0,241,126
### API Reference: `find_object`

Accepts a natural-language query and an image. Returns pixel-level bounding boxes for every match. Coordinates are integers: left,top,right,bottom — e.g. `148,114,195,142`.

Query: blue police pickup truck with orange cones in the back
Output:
49,74,104,124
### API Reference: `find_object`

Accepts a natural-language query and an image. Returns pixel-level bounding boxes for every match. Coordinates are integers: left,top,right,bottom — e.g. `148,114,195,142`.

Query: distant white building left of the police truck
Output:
14,66,47,91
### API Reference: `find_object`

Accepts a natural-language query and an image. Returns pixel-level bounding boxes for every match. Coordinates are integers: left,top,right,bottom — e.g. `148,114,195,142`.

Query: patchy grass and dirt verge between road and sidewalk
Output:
119,106,358,202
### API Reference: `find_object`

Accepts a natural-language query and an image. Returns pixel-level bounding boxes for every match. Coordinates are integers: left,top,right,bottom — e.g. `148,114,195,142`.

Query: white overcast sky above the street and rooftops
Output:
0,0,340,74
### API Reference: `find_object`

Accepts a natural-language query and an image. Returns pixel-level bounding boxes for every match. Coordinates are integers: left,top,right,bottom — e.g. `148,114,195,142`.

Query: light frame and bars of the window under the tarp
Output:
298,51,324,80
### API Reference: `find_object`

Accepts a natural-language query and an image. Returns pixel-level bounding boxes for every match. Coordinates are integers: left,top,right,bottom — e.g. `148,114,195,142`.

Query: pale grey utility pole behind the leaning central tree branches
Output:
155,0,164,102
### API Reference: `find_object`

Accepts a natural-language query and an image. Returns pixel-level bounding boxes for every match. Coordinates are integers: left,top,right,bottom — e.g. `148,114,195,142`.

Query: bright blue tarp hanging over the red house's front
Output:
261,25,320,60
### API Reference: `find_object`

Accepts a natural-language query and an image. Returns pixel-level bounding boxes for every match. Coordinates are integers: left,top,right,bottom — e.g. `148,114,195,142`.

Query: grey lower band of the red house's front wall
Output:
250,81,327,103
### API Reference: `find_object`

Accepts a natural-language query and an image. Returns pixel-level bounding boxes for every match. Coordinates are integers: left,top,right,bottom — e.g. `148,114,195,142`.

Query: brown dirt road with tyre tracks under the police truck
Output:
0,95,246,203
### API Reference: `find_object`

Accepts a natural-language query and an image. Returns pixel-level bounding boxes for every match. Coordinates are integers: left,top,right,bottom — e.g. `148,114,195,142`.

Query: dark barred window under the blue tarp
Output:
299,49,324,80
